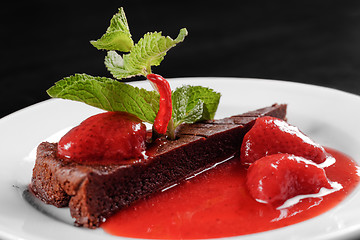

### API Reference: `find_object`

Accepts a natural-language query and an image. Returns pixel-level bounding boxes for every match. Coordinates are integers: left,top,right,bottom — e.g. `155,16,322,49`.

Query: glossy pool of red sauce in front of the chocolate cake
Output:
102,149,359,239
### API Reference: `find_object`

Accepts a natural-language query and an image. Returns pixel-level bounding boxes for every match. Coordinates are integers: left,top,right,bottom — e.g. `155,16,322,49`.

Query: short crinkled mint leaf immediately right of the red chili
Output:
170,85,221,128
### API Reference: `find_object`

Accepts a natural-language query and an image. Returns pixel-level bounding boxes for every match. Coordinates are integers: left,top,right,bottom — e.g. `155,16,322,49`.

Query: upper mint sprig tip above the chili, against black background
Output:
90,8,188,80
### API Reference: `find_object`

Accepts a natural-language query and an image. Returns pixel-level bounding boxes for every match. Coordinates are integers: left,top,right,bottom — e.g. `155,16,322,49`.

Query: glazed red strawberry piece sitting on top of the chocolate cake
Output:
58,112,146,162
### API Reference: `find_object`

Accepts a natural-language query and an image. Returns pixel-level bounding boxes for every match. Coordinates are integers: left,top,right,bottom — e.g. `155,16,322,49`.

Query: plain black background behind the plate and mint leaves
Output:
0,1,360,117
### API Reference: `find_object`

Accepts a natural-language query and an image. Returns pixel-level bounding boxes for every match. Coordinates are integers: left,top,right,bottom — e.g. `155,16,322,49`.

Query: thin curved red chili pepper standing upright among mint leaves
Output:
146,73,172,134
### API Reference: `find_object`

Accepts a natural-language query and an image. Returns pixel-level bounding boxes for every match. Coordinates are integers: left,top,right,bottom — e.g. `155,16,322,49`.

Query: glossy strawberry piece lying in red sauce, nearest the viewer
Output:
246,154,331,205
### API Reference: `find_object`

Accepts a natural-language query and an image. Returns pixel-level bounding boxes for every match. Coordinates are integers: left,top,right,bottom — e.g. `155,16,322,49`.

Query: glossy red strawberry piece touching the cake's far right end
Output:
240,117,327,164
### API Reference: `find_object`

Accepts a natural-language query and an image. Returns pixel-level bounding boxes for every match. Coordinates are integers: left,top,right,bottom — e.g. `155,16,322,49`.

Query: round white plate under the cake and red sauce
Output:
0,78,360,240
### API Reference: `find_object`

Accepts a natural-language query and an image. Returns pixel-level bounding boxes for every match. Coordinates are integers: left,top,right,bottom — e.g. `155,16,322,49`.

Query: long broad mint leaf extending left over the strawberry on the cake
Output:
47,74,160,123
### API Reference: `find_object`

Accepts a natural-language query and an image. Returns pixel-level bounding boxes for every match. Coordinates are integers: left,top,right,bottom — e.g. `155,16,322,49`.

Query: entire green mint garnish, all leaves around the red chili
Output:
47,8,220,139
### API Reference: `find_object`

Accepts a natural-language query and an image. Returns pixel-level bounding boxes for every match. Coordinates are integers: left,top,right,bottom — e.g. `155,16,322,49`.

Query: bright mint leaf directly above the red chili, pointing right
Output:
105,28,188,79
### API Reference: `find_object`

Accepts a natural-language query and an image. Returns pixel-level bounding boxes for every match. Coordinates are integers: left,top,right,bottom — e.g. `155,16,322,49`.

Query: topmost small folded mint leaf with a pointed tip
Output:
90,8,134,52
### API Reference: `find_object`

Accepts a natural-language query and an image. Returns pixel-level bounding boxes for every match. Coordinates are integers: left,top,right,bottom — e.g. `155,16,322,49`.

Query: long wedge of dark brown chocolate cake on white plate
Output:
30,104,286,228
